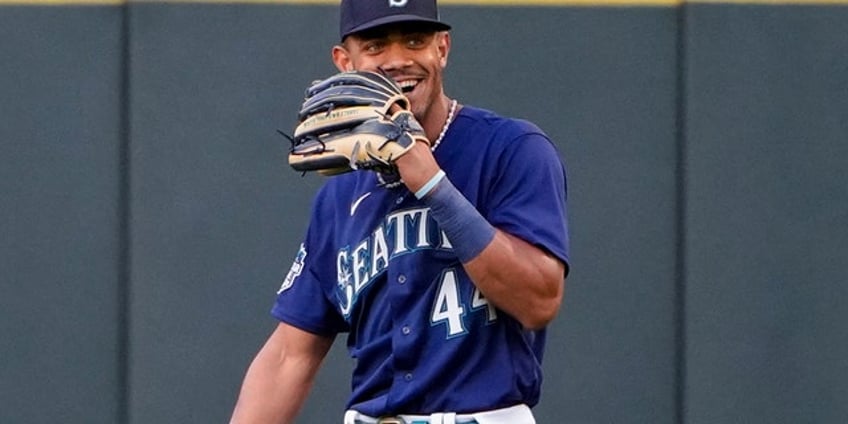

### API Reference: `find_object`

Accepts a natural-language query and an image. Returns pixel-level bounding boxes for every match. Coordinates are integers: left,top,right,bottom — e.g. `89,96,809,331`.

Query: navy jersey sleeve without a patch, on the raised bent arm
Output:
487,123,569,267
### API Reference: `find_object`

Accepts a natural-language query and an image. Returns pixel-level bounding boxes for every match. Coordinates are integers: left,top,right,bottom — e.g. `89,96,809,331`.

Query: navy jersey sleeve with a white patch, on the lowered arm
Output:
271,186,348,336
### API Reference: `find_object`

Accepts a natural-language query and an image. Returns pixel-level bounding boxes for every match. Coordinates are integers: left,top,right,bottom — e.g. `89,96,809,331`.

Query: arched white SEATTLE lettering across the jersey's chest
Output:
336,208,453,317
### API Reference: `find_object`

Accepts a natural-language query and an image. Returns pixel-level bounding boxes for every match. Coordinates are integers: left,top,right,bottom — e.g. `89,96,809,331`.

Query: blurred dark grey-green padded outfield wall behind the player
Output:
0,0,848,424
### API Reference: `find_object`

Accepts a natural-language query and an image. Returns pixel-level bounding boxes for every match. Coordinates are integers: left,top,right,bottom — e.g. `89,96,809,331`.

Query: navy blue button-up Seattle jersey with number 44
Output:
272,106,568,416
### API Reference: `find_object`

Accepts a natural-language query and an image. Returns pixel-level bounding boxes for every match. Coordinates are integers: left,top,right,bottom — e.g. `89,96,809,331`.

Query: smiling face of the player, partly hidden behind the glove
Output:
333,24,450,123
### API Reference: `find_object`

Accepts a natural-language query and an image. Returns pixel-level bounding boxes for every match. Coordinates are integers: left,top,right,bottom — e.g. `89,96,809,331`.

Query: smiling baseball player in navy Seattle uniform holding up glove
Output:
231,0,568,424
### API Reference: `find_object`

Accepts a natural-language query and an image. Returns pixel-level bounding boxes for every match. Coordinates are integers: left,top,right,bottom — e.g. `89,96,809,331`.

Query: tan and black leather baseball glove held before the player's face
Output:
289,71,430,175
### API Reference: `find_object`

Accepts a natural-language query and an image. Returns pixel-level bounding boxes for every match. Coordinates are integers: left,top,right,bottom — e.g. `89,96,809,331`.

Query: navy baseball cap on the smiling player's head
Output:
339,0,450,40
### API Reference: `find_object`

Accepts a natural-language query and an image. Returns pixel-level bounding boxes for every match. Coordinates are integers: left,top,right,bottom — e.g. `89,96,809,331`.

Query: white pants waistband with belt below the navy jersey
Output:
344,405,536,424
